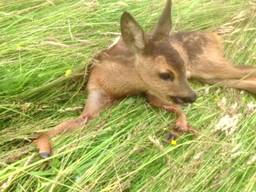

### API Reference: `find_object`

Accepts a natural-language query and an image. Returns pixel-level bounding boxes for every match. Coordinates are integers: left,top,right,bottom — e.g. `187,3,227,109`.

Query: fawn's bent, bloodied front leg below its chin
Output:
147,95,195,133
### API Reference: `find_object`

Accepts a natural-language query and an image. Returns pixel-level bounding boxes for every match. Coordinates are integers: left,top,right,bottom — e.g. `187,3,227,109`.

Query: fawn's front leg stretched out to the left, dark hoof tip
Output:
34,89,113,158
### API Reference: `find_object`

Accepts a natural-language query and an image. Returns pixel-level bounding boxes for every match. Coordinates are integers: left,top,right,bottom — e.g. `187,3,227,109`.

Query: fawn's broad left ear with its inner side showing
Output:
121,12,146,53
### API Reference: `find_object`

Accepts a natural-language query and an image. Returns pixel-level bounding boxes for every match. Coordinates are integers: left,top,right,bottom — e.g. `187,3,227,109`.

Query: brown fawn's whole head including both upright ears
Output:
121,0,196,103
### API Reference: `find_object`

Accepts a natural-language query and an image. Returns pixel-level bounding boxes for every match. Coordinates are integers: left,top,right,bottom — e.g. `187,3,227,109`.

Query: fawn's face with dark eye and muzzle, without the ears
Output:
136,40,196,103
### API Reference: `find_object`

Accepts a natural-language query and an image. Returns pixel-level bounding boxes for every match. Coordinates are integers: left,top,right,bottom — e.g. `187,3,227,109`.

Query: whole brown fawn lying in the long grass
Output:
35,0,256,157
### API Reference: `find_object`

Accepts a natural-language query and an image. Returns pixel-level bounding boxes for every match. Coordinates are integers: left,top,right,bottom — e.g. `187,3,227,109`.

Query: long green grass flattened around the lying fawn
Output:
0,0,256,192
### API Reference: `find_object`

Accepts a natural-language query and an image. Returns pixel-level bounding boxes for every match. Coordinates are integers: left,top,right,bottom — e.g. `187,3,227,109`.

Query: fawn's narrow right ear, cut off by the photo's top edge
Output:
153,0,172,40
